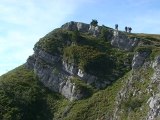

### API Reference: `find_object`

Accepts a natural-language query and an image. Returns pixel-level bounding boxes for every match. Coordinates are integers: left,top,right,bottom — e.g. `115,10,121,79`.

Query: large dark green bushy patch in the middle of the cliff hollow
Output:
64,46,114,77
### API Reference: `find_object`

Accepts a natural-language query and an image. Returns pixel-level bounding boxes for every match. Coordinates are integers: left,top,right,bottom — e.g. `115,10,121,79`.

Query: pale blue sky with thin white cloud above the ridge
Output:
0,0,160,75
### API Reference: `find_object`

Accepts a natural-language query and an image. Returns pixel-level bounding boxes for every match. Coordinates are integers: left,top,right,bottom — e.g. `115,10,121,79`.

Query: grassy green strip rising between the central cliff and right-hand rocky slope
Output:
58,75,130,120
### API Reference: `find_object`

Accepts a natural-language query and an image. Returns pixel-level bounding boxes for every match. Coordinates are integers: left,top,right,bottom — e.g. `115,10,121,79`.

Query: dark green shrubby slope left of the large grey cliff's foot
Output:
0,66,67,120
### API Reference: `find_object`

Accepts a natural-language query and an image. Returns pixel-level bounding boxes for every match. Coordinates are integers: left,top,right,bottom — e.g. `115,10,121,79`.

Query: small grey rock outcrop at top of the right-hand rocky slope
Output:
132,52,150,69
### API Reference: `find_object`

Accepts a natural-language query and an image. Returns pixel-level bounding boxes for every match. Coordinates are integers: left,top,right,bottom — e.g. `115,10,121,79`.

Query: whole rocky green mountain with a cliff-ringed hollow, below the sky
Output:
0,20,160,120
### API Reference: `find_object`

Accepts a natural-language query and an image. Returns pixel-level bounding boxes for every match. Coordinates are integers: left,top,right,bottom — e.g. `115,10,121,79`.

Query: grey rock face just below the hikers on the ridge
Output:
111,30,139,51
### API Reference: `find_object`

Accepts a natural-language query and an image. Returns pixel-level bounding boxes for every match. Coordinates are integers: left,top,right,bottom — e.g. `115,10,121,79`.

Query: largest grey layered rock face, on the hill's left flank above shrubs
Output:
26,48,84,101
